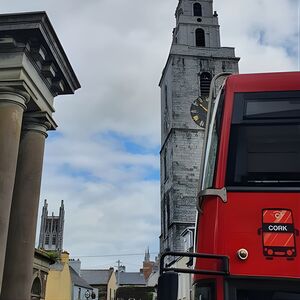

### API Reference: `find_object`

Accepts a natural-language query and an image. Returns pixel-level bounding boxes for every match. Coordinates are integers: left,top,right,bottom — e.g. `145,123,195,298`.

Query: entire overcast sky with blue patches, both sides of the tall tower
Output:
1,0,299,271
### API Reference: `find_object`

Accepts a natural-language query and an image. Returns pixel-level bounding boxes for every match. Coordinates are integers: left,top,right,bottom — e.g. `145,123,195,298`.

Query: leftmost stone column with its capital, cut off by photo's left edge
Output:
0,87,29,292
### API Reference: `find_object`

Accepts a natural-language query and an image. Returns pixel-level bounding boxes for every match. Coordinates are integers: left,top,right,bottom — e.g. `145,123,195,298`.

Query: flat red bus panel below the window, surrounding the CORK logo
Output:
218,192,300,278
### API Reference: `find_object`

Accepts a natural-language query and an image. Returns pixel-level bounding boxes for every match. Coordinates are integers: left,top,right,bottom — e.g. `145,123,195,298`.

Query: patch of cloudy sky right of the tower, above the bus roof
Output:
215,0,299,73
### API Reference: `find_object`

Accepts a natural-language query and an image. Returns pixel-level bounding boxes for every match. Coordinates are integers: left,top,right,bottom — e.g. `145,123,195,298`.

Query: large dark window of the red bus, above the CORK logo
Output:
226,92,300,187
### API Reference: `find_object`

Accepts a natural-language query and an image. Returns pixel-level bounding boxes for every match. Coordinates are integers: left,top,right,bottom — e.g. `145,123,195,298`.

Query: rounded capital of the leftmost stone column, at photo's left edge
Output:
0,86,30,110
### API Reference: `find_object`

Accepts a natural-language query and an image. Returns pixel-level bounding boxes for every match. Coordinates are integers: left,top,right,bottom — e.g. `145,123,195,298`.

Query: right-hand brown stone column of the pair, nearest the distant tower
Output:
0,114,48,300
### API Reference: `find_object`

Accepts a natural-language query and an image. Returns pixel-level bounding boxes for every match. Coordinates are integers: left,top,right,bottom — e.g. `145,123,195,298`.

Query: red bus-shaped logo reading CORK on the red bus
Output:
262,209,296,257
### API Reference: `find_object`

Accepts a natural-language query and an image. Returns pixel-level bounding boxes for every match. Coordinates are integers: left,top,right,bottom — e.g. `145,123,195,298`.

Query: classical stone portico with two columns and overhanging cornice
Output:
0,12,80,300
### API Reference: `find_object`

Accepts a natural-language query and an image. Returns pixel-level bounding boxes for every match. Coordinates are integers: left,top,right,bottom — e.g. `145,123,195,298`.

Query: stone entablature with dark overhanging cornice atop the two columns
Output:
0,12,80,119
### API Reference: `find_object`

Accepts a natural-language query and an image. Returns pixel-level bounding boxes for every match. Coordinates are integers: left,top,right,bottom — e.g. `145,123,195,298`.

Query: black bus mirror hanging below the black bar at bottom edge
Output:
157,272,178,300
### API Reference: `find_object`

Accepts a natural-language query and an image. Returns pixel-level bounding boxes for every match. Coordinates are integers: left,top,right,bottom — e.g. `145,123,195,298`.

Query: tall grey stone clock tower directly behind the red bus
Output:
159,0,239,252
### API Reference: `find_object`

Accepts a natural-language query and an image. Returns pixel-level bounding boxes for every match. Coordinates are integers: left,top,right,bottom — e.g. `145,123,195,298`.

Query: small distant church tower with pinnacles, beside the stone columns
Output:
39,200,65,252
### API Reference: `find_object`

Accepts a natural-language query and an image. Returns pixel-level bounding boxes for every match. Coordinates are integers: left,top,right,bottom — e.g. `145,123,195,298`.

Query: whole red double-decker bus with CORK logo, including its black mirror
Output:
158,72,300,300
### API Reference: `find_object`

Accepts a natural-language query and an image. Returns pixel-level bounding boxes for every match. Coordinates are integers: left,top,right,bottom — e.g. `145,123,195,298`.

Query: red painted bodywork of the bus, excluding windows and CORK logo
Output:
195,72,300,288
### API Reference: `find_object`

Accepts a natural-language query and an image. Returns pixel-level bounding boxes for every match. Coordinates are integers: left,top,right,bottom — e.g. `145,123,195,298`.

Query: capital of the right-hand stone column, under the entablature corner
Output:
22,112,57,137
